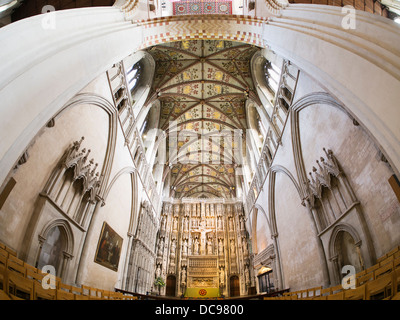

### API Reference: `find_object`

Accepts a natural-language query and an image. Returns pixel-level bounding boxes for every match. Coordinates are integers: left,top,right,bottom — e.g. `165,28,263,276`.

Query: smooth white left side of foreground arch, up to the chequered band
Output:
0,8,141,189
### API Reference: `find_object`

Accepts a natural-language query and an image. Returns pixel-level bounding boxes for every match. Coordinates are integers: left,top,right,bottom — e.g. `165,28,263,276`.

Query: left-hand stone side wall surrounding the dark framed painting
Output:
0,73,155,290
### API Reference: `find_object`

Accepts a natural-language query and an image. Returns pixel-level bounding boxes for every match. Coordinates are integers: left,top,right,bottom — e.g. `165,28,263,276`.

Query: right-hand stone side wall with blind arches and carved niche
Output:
249,64,400,290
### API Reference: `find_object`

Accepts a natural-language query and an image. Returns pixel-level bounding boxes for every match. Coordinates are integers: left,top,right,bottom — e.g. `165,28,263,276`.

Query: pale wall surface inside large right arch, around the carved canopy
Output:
299,105,400,257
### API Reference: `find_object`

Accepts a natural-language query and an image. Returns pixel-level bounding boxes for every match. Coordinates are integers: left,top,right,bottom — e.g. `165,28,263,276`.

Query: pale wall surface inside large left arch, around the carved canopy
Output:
0,105,109,251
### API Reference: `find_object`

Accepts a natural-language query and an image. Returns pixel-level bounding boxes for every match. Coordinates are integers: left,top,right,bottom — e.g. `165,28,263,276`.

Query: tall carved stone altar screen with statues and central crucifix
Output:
155,199,250,296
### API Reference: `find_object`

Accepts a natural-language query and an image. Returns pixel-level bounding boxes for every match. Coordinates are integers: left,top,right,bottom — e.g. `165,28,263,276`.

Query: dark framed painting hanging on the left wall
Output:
94,221,123,271
